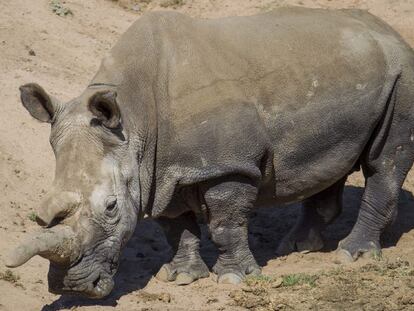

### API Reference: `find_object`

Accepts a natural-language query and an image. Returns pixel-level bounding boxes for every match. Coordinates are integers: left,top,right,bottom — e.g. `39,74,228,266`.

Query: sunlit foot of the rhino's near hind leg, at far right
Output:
337,233,381,262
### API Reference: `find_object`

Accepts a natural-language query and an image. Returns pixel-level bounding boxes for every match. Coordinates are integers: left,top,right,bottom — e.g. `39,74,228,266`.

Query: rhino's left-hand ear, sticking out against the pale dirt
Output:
19,83,58,123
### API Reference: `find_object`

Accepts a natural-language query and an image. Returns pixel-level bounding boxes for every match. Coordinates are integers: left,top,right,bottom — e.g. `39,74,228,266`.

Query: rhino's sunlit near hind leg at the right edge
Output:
338,72,414,261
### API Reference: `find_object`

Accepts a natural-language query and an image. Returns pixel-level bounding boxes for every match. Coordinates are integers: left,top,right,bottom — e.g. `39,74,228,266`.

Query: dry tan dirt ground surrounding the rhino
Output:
0,0,414,310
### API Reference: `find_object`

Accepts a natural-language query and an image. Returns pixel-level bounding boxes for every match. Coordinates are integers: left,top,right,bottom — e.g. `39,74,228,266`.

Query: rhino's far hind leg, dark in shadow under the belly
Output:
277,178,346,256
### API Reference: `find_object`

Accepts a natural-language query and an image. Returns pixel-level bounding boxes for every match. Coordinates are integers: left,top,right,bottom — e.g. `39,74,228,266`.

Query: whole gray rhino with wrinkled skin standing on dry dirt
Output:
5,8,414,298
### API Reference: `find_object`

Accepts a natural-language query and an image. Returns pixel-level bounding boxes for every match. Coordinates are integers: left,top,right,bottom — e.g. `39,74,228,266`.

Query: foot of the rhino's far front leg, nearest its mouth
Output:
156,262,210,285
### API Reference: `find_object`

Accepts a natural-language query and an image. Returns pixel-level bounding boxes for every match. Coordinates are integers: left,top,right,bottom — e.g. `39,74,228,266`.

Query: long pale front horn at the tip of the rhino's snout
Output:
6,225,79,268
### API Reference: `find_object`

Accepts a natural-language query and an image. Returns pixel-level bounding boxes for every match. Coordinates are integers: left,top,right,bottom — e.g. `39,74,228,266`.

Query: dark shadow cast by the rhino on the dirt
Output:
42,186,414,311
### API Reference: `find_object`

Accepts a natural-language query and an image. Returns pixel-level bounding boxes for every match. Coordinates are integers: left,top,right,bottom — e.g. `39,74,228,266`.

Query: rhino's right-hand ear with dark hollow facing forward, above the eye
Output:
88,91,121,129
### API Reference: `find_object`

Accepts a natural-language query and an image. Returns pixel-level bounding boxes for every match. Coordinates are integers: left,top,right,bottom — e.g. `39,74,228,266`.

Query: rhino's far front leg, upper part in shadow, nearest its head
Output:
157,212,210,285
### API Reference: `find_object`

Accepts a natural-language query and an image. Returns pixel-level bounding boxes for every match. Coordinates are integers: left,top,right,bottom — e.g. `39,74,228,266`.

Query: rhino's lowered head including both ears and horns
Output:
6,84,141,298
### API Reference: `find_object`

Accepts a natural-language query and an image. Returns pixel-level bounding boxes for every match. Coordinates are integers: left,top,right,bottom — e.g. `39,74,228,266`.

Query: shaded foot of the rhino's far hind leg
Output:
276,229,324,256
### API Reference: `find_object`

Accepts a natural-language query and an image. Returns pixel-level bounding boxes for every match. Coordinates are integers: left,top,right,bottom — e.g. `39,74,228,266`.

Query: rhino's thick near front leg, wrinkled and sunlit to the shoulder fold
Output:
204,179,260,284
